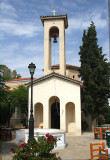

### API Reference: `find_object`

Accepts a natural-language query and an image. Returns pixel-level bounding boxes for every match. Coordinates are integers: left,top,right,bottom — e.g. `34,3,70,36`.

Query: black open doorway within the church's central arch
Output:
51,101,60,129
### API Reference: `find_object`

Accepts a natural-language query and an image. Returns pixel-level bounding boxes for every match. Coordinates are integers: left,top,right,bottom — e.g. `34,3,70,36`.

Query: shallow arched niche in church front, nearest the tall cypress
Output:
66,102,75,132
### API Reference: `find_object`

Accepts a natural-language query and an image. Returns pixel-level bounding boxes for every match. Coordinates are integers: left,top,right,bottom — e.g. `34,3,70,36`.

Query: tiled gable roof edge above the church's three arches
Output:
27,72,82,86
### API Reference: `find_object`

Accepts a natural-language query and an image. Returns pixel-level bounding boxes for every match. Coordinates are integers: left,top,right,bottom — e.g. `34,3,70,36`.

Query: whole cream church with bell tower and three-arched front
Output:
28,14,82,135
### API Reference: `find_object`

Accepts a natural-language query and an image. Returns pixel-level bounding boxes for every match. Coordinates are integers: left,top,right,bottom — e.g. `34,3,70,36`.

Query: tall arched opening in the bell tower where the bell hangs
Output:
49,26,59,66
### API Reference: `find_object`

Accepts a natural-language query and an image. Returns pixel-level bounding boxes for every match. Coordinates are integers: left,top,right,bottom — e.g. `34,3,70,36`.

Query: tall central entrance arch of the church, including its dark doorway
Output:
49,96,60,129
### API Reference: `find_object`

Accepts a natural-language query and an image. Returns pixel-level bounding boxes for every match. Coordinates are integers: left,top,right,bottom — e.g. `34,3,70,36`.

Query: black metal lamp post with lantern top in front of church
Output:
28,63,36,139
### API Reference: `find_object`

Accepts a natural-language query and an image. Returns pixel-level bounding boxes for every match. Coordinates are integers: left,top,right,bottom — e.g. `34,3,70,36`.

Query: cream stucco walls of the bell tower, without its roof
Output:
44,19,66,75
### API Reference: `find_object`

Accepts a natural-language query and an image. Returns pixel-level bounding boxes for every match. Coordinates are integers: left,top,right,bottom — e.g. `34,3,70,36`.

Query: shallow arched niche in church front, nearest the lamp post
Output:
34,103,43,127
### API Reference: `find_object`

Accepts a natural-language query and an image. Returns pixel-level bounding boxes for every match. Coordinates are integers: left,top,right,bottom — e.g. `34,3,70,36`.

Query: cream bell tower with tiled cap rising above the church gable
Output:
40,13,68,75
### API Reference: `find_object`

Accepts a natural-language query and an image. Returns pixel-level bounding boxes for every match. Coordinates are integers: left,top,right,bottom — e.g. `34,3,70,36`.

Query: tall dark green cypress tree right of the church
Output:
79,22,110,120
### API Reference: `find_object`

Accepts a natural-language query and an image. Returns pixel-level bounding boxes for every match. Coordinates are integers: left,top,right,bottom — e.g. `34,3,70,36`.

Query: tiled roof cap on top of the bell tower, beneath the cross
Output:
40,14,68,28
